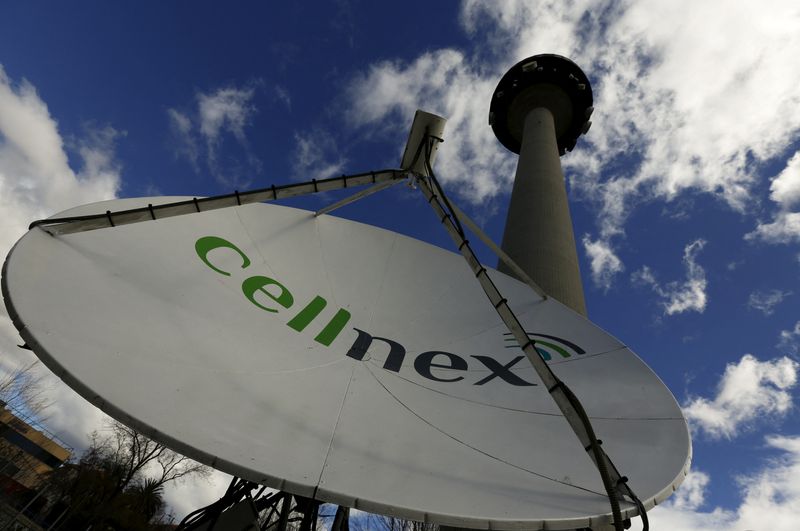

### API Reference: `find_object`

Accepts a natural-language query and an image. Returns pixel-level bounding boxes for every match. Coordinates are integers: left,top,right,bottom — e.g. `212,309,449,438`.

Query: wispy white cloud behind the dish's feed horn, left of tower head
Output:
347,49,515,203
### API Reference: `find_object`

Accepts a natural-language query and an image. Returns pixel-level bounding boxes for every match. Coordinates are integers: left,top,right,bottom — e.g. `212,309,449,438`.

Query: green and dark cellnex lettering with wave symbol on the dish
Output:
194,236,584,386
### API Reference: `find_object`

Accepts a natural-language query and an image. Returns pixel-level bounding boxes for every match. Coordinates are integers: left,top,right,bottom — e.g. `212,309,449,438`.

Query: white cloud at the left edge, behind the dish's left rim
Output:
0,66,120,446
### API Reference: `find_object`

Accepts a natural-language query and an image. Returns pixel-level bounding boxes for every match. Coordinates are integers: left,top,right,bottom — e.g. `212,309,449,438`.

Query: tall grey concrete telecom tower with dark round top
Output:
489,54,594,316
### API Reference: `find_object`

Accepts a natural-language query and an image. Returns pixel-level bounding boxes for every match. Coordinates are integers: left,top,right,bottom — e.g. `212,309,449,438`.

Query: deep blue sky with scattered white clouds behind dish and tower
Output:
0,0,800,530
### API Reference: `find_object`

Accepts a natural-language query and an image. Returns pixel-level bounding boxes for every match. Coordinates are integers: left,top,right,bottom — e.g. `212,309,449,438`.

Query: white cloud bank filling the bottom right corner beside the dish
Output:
631,435,800,531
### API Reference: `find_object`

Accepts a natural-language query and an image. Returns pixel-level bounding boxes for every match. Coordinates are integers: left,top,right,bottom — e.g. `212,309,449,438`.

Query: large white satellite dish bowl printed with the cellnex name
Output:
2,196,690,529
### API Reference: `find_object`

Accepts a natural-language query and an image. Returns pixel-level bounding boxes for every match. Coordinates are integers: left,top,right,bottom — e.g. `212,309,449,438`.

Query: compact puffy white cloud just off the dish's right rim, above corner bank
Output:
683,354,800,439
